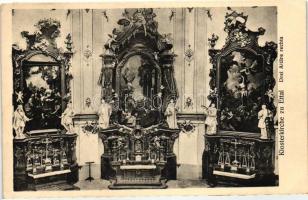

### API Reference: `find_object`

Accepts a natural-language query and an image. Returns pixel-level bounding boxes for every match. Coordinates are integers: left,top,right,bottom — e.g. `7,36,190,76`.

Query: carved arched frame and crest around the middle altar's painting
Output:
99,9,178,110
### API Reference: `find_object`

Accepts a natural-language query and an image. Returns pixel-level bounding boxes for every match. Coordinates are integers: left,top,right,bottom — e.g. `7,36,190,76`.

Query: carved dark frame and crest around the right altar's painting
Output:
208,11,277,130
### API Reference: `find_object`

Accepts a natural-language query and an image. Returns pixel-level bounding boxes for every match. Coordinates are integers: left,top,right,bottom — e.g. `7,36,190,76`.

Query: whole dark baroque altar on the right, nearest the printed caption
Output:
202,8,277,186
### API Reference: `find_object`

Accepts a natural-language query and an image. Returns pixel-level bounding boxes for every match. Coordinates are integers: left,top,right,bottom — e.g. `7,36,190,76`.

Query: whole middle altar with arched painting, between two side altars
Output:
98,8,180,189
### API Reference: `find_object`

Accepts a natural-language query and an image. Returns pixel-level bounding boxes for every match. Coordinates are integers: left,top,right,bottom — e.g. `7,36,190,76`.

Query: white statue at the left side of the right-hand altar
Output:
205,103,217,135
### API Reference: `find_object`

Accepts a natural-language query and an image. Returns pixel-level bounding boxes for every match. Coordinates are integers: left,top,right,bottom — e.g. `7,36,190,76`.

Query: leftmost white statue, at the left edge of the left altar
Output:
13,105,30,139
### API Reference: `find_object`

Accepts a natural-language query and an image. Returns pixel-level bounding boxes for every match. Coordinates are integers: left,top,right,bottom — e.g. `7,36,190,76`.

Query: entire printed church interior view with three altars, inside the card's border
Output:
12,7,279,191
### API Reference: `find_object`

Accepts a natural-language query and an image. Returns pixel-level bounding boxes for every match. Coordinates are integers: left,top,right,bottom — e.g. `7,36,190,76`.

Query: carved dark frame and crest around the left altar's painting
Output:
12,19,73,110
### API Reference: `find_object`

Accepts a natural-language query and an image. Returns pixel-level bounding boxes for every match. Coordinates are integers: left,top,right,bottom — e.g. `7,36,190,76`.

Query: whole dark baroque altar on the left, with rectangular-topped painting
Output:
12,19,78,191
